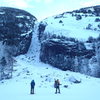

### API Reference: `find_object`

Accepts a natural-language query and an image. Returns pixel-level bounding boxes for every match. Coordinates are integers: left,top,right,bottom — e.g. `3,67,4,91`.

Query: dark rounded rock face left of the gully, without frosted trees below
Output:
0,7,36,55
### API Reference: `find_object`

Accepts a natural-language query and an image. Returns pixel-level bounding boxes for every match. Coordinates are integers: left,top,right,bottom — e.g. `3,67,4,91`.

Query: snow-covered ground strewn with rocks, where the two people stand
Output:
0,55,100,100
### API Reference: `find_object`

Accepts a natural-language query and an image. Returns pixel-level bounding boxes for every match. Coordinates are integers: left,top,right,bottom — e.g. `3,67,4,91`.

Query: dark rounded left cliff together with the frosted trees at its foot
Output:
0,7,36,80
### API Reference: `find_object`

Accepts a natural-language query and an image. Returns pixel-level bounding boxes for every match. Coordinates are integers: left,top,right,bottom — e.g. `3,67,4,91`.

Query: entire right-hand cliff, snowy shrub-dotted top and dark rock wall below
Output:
38,6,100,77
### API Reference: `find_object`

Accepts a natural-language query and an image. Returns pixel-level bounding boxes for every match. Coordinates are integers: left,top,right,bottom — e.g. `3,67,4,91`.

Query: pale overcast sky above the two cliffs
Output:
0,0,100,20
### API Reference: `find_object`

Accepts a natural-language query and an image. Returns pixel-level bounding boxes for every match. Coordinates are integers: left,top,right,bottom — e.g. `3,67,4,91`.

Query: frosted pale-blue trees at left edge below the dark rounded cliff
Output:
0,45,15,80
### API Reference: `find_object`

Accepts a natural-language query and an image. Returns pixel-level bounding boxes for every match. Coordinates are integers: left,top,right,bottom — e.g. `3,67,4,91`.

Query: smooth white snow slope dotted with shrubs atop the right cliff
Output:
43,7,100,41
